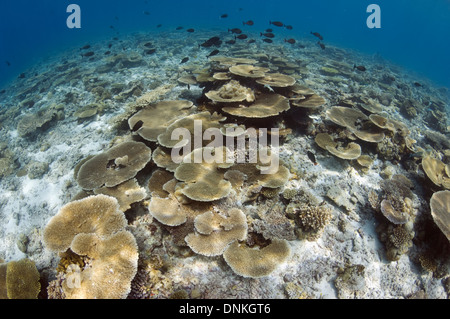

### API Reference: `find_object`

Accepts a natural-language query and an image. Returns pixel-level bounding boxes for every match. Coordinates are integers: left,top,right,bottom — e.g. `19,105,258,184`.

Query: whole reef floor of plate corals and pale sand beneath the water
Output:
0,30,450,299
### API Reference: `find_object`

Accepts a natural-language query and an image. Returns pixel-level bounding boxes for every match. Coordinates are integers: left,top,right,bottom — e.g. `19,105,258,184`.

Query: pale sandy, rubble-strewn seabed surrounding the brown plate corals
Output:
0,31,450,299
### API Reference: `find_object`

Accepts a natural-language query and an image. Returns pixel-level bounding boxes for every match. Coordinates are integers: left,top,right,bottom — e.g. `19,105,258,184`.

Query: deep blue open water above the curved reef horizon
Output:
0,0,450,88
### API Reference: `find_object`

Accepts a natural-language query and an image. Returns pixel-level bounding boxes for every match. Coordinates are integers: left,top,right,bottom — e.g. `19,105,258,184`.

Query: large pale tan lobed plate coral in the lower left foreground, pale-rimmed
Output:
44,195,138,299
